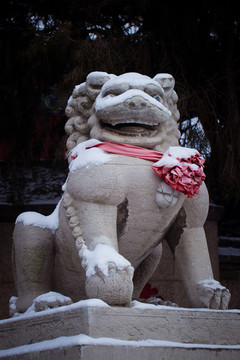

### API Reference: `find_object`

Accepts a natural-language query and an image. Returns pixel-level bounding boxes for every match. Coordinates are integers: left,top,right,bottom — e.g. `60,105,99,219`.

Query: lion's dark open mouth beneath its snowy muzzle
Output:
99,120,159,136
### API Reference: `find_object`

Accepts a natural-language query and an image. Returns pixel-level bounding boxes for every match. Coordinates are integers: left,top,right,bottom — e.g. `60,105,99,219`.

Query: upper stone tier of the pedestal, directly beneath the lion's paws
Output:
0,304,240,349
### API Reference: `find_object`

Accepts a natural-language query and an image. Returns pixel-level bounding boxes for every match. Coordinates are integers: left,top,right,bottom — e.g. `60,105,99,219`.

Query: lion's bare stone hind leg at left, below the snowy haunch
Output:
13,214,54,312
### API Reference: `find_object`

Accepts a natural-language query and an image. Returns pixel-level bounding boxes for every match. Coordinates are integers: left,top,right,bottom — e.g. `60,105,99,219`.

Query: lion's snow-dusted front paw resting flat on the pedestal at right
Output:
197,279,231,310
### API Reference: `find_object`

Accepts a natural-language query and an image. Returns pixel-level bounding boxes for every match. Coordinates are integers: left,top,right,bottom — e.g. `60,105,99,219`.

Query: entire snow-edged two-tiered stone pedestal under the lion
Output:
0,300,240,360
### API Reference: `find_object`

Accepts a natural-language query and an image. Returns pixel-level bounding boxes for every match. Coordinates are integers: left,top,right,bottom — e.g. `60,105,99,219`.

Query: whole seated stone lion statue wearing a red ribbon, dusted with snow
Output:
13,72,230,312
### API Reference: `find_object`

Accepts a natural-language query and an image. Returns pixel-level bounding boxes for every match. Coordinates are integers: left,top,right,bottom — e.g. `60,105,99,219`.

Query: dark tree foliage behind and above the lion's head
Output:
0,0,240,222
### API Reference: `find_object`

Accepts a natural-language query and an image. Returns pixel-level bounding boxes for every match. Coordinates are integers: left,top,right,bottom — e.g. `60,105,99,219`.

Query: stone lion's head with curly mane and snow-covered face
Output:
65,72,179,160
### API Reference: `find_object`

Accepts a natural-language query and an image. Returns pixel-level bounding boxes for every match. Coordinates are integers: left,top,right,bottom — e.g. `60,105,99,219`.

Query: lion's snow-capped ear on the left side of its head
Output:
86,71,110,101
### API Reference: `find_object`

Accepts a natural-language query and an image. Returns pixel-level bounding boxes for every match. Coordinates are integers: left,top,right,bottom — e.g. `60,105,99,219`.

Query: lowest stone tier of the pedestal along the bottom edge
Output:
0,344,240,360
